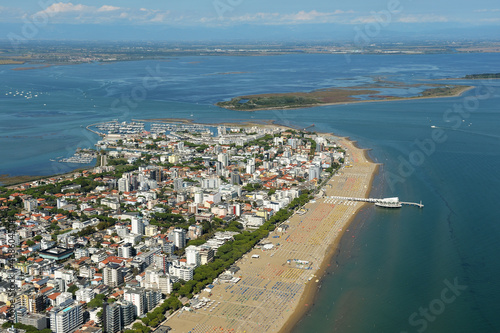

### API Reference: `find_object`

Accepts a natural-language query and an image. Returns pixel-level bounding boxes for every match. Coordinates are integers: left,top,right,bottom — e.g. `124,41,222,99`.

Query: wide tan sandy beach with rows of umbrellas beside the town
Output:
163,139,377,333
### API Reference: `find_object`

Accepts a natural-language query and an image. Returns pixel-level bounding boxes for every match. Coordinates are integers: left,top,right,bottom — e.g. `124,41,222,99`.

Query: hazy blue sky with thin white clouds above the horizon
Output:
0,0,500,40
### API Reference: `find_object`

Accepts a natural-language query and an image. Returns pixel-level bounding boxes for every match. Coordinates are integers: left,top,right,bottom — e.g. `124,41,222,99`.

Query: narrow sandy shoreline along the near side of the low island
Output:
214,86,476,112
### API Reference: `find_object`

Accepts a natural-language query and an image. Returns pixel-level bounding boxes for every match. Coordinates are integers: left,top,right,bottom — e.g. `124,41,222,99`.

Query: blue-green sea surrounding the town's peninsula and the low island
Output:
0,53,500,333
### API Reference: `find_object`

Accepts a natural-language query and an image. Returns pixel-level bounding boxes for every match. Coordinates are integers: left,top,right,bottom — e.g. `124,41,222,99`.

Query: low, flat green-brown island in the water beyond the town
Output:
215,82,472,111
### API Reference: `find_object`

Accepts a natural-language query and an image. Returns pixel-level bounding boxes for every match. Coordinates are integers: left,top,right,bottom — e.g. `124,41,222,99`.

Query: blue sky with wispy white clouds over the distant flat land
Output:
0,0,500,38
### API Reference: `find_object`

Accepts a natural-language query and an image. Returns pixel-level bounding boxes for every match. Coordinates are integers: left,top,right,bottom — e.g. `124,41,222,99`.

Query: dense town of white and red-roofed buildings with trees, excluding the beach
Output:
0,122,349,333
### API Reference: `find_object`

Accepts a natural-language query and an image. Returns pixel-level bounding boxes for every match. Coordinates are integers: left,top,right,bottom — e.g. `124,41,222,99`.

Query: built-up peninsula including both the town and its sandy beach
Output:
0,120,377,333
